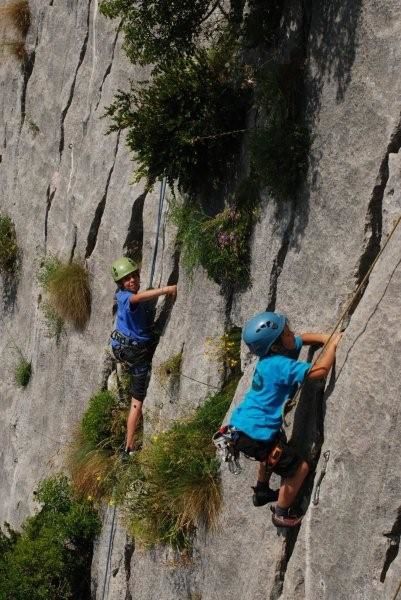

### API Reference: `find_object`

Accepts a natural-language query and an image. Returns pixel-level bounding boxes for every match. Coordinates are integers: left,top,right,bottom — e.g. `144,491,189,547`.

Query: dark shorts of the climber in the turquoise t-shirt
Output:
235,431,303,478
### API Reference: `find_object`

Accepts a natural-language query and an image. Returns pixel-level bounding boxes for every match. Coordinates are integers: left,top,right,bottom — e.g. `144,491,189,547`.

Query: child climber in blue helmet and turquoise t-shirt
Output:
229,312,341,527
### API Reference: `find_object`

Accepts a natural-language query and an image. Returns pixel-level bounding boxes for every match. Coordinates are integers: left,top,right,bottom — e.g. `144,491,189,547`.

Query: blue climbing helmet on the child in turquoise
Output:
242,312,287,356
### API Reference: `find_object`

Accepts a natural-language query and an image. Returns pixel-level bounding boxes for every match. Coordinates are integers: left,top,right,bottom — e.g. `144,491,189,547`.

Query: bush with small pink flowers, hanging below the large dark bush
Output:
170,182,259,289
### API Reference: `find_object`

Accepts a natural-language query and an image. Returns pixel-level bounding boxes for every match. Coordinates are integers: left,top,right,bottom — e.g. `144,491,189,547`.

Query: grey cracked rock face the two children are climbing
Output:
0,0,401,600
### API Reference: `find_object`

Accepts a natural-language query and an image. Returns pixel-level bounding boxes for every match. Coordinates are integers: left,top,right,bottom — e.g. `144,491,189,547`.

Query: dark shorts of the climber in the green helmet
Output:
112,345,154,402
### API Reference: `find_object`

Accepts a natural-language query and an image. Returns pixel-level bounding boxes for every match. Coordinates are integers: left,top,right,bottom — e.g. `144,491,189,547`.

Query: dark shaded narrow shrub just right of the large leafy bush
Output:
250,65,310,199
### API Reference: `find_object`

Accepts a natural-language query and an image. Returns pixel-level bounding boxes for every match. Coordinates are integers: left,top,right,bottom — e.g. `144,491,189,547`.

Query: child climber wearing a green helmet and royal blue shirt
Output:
111,257,177,454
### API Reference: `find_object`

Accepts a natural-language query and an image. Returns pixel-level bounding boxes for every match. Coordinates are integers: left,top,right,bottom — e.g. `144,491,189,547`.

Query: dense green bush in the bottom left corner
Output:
0,475,100,600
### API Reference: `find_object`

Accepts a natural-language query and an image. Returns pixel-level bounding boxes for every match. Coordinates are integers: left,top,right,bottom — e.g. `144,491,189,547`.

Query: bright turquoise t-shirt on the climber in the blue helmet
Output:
229,336,312,441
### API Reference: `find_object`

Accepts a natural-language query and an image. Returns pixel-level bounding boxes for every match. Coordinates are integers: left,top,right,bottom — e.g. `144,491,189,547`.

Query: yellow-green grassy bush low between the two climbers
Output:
116,380,237,548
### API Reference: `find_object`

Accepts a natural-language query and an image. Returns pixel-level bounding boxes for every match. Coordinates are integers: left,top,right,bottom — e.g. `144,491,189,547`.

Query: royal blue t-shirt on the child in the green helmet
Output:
111,290,152,348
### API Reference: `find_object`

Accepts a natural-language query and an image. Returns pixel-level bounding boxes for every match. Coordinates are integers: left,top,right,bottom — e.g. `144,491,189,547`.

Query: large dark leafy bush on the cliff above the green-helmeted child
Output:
106,44,250,195
